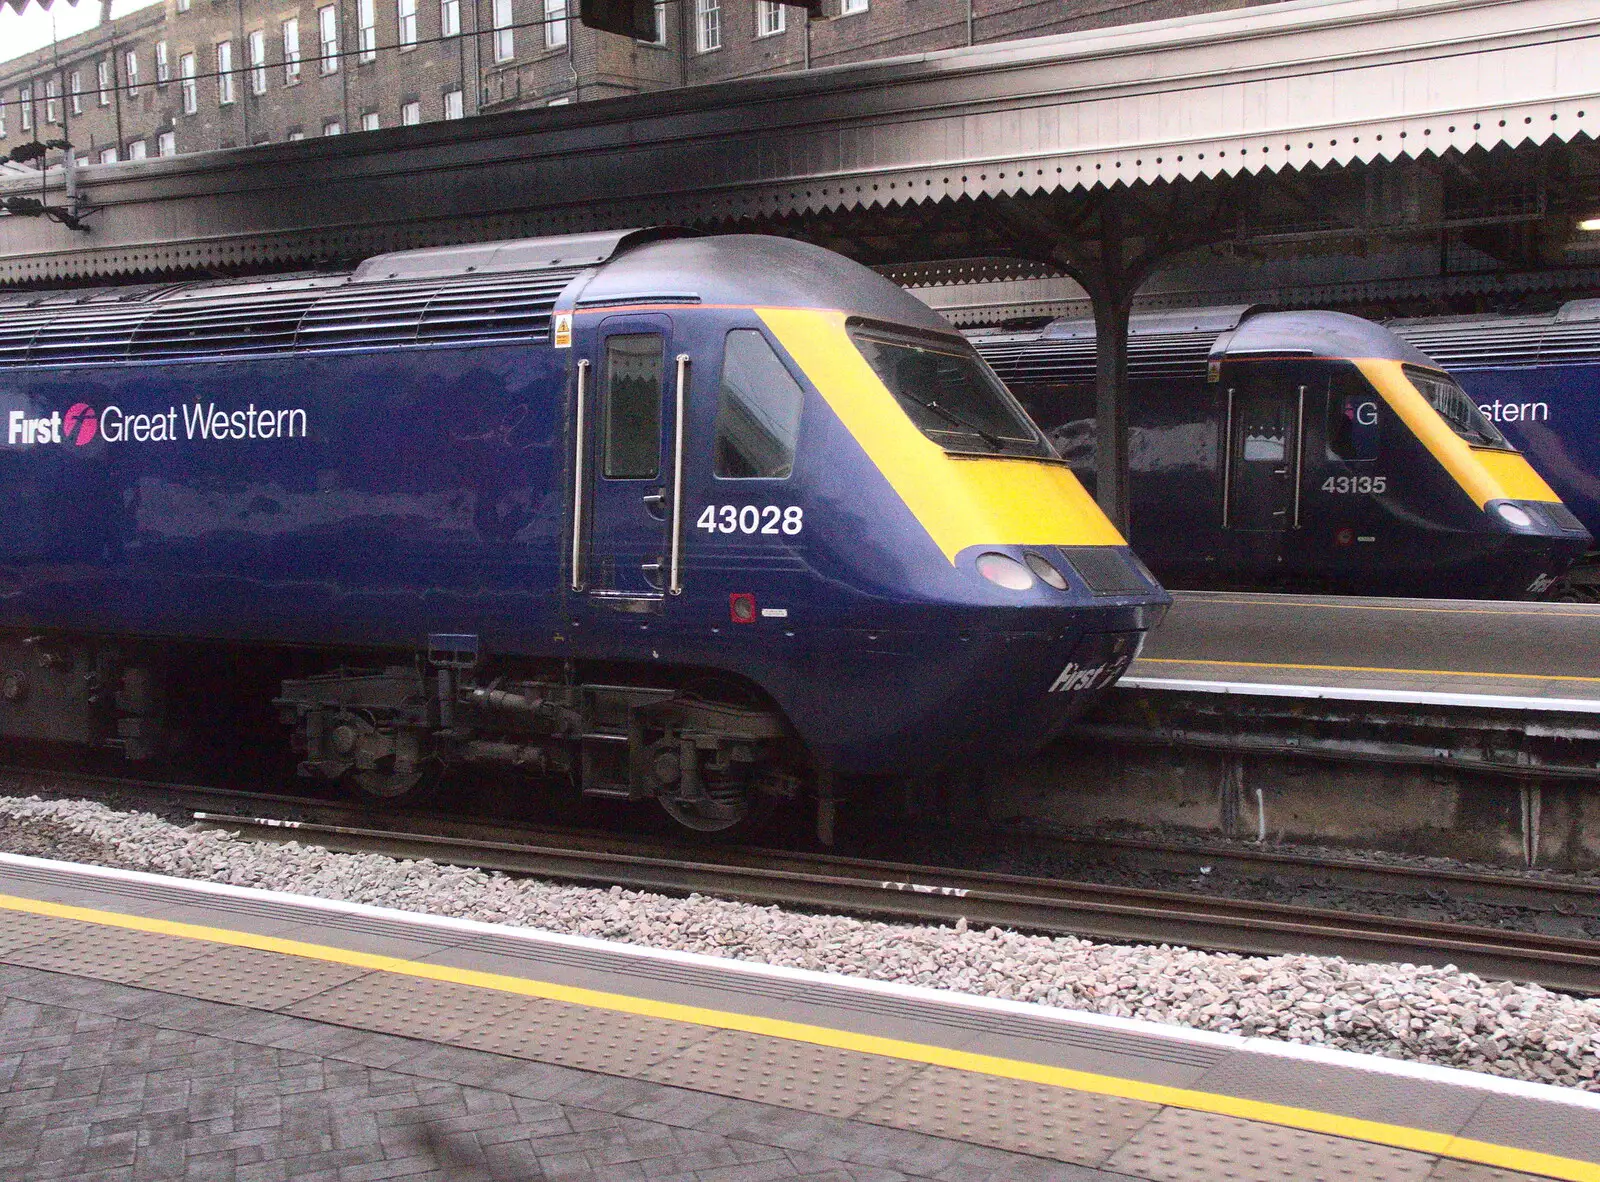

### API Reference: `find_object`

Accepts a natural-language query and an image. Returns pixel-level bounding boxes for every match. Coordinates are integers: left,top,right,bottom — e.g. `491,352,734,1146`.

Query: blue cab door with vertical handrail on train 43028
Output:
571,315,680,614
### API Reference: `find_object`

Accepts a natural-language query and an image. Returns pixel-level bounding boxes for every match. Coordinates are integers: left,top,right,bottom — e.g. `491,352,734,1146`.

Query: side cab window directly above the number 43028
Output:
712,328,805,480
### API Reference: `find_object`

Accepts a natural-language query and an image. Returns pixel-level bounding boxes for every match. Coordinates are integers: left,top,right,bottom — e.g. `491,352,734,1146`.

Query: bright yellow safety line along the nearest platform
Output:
0,894,1600,1182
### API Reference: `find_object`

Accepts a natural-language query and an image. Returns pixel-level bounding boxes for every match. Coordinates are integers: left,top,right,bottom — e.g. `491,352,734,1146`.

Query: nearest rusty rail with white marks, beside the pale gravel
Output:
195,813,1600,993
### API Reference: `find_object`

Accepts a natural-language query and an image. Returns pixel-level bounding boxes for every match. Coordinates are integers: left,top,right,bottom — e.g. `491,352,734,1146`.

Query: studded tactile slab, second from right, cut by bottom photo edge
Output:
1106,1108,1435,1182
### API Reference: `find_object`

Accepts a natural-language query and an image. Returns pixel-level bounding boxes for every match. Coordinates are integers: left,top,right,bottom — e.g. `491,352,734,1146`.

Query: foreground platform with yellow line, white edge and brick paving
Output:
0,856,1600,1182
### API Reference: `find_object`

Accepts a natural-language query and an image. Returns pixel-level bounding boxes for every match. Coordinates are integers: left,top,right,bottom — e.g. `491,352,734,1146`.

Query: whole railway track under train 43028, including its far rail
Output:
0,766,1600,993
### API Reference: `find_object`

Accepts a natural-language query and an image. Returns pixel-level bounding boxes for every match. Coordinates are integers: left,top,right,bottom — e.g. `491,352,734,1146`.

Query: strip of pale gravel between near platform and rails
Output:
0,797,1600,1091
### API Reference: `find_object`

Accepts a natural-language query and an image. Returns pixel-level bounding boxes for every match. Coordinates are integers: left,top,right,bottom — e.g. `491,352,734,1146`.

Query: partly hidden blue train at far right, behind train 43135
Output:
1387,299,1600,603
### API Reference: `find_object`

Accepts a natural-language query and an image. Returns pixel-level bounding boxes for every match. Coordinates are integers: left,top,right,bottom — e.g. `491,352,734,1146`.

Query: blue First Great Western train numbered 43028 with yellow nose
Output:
0,229,1170,840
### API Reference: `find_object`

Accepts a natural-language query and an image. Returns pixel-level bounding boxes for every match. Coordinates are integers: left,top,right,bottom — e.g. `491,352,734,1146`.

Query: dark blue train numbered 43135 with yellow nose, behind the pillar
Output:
968,305,1592,598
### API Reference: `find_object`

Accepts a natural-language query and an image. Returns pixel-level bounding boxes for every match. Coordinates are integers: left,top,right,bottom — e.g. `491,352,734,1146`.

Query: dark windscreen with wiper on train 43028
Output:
850,323,1056,459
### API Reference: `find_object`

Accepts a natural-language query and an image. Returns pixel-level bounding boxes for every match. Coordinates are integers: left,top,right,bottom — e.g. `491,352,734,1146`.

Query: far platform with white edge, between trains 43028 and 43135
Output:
1120,592,1600,713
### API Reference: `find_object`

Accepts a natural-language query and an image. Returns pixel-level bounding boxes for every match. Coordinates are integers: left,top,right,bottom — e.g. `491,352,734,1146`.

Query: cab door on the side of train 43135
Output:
1222,372,1306,534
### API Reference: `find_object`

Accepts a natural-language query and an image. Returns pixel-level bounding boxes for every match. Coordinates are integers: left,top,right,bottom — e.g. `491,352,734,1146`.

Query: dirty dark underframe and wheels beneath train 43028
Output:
0,633,812,841
